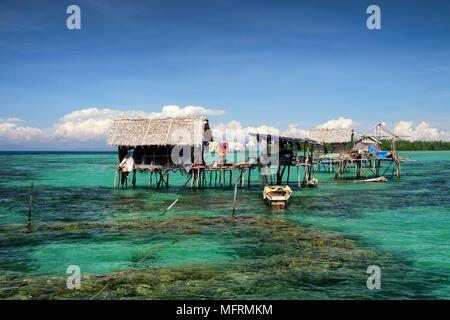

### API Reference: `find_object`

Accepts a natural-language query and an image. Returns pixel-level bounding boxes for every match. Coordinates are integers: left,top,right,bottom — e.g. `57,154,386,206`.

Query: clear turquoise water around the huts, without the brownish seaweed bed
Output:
0,151,450,299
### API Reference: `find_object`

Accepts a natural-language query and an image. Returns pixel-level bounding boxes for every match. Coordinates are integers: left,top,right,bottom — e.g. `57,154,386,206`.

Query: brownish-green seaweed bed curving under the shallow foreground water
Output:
0,215,418,299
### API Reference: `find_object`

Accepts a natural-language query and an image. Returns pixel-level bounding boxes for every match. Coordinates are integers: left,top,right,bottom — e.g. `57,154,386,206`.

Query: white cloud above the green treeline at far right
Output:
394,121,450,141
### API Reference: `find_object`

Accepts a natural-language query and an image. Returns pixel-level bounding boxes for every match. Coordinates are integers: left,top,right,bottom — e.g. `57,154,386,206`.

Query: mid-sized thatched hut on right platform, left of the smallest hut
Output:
308,129,354,153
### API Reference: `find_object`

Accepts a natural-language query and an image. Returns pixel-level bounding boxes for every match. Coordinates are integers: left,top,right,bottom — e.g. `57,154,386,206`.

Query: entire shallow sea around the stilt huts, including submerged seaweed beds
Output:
0,151,450,299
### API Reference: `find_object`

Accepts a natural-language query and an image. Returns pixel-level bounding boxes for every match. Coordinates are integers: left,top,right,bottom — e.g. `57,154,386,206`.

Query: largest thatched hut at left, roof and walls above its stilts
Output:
107,117,211,169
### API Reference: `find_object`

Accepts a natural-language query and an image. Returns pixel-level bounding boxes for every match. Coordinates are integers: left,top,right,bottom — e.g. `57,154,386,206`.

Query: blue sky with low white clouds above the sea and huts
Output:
0,0,450,150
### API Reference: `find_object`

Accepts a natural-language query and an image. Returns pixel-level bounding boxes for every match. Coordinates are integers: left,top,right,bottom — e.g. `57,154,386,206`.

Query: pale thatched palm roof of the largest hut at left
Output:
108,117,209,147
